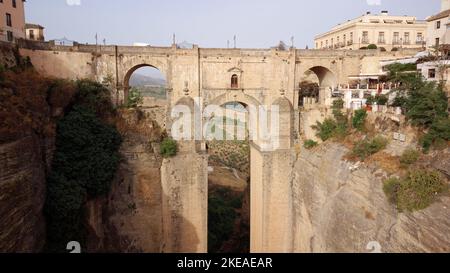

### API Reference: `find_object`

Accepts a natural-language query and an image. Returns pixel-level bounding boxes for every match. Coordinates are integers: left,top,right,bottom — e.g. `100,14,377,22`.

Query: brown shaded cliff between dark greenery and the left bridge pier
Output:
87,110,162,253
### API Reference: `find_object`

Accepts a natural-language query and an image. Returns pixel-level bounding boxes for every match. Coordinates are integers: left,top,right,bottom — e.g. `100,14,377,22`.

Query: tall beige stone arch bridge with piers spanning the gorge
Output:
20,43,414,252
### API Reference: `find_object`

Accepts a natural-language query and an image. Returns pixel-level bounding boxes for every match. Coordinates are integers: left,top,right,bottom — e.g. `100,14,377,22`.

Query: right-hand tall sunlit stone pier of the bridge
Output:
250,144,294,253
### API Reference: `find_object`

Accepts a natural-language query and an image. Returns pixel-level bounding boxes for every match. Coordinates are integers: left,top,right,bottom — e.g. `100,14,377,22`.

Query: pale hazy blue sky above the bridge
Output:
26,0,441,48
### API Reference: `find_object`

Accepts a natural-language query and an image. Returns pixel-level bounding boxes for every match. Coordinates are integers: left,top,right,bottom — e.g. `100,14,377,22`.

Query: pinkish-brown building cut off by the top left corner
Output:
0,0,25,42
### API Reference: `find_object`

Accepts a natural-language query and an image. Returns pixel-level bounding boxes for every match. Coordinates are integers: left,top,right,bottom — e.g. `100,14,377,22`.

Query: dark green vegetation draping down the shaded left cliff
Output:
45,81,121,252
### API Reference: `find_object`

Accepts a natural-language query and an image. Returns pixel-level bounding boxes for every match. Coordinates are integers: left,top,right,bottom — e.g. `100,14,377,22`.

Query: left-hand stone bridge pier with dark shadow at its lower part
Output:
161,146,208,253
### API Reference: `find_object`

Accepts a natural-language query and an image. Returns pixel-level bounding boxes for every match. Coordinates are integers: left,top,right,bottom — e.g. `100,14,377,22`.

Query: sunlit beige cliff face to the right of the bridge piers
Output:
292,143,450,252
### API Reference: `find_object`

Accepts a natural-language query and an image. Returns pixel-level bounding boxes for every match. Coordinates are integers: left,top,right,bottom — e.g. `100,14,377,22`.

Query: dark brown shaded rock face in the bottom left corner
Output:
0,135,54,252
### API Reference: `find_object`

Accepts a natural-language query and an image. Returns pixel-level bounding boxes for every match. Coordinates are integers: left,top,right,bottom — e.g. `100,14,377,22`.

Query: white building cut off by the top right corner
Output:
427,0,450,47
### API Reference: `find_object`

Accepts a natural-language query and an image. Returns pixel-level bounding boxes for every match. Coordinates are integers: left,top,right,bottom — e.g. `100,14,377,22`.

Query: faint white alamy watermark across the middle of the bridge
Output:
171,98,285,151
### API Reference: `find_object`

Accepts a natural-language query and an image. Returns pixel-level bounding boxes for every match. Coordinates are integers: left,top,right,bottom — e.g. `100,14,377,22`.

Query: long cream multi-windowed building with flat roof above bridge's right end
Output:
314,11,427,51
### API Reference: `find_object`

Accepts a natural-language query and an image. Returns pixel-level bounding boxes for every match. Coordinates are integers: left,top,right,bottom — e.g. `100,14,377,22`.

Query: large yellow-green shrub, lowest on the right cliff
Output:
383,170,448,212
